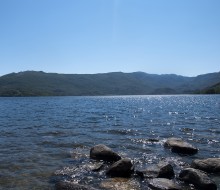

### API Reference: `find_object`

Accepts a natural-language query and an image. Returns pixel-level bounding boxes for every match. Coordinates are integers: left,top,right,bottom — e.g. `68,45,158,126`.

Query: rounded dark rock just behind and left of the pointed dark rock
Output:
90,144,121,162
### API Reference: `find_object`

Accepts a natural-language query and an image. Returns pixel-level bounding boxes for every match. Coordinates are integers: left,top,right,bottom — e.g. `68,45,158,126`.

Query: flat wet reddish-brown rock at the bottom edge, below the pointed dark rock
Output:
100,177,141,190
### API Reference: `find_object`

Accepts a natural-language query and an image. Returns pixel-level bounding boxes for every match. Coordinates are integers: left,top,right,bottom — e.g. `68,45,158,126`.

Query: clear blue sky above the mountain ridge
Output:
0,0,220,76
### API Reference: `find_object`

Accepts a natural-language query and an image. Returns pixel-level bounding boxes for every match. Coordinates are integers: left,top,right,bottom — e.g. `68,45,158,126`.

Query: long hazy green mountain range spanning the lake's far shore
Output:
0,71,220,96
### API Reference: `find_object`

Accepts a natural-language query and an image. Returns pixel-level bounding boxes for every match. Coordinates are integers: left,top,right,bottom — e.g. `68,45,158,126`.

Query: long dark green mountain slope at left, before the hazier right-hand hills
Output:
0,72,151,96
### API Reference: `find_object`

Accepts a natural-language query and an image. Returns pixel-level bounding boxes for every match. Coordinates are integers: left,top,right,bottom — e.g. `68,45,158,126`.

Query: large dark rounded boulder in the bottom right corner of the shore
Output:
179,168,217,190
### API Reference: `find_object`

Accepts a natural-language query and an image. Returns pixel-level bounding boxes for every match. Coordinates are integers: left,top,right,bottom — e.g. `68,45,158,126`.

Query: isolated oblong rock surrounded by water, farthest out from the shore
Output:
164,137,198,154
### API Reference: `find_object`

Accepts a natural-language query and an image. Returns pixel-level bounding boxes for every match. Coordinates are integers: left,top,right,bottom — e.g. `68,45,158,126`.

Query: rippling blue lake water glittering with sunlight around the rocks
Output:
0,95,220,189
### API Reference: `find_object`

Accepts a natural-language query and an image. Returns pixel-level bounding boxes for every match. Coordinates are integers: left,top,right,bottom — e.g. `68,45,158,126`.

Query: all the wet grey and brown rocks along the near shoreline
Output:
55,138,220,190
